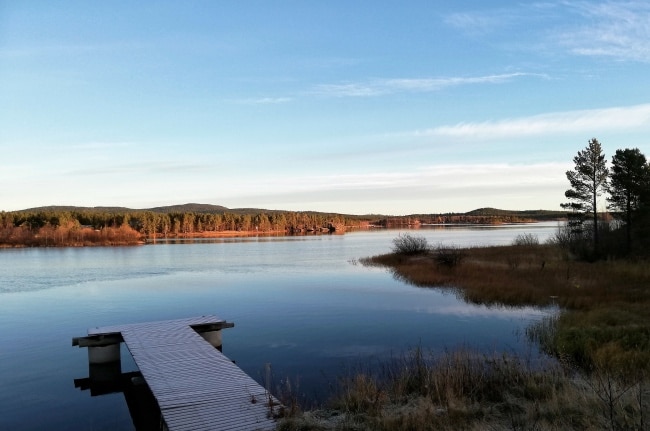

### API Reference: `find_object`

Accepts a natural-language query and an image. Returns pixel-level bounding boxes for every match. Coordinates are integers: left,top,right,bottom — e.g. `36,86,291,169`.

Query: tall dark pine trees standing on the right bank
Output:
561,138,650,258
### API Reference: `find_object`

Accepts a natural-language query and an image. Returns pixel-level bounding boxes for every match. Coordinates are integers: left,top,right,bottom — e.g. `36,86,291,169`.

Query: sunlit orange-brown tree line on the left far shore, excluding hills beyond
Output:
0,210,364,246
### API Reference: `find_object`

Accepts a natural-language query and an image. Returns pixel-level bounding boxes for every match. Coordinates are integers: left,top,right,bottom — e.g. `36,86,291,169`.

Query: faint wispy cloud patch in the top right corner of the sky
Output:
443,0,650,62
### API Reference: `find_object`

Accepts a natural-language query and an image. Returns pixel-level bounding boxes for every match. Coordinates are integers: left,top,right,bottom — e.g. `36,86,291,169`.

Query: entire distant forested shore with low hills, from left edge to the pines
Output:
0,204,565,247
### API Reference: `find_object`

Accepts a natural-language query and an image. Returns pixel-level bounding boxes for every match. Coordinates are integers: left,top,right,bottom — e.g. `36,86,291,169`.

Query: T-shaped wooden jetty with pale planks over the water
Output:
72,316,281,431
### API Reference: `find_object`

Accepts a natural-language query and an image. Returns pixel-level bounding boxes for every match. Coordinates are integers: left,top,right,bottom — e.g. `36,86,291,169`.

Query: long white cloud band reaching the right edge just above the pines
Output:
414,104,650,139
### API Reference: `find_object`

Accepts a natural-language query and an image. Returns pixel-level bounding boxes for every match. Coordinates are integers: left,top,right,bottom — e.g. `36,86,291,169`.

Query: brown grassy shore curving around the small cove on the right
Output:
280,245,650,430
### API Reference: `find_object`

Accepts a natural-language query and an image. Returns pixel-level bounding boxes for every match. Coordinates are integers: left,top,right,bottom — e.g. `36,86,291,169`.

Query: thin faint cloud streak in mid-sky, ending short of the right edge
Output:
311,72,548,97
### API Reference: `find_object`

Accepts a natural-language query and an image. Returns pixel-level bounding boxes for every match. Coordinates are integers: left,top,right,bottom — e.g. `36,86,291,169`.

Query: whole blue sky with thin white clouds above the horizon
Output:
0,0,650,215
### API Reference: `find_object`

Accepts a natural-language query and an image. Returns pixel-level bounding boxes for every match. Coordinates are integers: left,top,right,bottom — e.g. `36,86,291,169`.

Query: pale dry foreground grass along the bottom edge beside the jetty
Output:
278,349,647,431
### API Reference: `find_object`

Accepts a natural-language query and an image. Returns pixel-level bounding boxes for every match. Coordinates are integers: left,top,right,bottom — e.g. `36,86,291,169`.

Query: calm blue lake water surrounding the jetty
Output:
0,223,557,430
